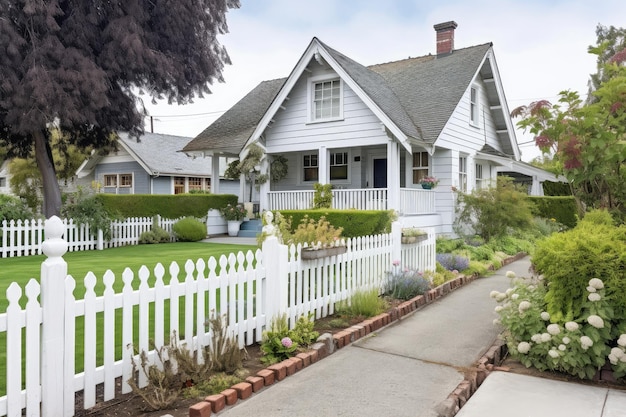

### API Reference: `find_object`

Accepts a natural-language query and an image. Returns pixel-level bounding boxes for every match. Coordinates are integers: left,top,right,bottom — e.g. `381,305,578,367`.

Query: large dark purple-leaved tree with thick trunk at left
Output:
0,0,240,217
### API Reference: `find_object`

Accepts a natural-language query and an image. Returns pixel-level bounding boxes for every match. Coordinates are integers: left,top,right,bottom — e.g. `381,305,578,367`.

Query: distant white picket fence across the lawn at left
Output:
0,217,177,258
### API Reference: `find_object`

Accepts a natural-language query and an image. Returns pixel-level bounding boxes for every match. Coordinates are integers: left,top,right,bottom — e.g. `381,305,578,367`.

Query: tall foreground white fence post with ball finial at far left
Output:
41,216,68,417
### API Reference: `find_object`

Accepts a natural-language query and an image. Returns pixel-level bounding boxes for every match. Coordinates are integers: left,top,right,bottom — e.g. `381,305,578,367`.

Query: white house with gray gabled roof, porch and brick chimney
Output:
182,22,557,234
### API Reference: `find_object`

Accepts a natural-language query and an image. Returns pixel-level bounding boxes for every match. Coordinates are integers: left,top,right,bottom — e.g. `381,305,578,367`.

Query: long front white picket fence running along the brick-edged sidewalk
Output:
0,217,435,417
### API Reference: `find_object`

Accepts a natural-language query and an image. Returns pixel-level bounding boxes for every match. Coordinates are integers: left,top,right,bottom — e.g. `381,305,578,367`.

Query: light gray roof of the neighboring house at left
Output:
76,133,211,177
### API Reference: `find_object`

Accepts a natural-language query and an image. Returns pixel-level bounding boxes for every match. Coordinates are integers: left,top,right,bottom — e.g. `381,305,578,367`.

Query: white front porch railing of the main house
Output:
267,188,436,216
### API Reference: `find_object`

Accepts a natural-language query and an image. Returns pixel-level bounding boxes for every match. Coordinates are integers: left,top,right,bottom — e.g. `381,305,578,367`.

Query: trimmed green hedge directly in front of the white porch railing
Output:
280,209,394,237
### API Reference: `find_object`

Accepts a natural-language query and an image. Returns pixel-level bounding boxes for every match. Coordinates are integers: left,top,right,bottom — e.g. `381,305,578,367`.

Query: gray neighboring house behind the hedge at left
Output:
76,133,239,194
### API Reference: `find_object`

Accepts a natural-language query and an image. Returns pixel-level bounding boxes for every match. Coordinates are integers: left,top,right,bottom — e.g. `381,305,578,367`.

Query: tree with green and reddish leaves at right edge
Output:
511,33,626,220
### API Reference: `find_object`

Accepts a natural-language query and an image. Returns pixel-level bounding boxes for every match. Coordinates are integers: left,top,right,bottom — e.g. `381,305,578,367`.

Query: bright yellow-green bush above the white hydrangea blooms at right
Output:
533,211,626,317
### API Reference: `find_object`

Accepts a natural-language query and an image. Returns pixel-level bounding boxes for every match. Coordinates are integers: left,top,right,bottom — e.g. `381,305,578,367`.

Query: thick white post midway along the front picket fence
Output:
261,236,289,321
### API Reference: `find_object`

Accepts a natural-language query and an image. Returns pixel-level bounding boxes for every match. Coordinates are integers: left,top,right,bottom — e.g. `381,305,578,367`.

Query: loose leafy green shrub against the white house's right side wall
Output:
454,177,532,241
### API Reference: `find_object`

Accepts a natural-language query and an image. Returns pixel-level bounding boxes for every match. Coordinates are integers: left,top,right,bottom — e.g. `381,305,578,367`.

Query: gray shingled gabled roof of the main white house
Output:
183,38,513,154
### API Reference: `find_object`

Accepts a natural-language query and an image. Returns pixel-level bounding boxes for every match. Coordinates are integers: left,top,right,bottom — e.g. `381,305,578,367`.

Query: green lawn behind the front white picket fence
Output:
0,243,256,395
